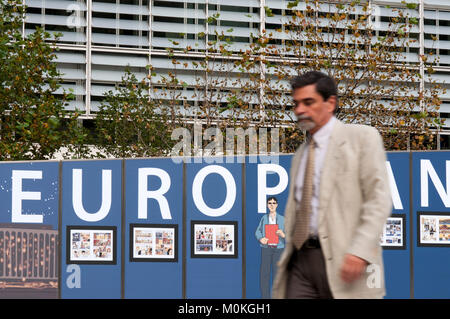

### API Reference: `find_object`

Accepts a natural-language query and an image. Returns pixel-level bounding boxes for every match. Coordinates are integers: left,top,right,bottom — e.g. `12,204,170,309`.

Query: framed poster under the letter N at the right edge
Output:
417,212,450,247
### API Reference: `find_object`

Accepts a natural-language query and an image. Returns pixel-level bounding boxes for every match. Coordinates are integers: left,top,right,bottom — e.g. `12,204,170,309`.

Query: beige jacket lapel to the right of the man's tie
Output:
319,121,345,226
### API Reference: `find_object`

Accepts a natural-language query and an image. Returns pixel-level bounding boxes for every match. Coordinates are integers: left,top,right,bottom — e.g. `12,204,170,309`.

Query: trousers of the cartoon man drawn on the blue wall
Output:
259,247,283,299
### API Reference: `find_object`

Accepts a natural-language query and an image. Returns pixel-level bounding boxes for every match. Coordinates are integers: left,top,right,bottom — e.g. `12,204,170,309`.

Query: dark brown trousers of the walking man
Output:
286,248,333,299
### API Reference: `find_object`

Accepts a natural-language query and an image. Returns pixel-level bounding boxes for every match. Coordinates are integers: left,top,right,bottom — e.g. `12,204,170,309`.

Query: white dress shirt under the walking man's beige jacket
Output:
295,116,336,236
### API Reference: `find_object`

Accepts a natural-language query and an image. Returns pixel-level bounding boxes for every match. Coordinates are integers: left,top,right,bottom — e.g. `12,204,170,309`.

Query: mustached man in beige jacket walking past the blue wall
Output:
272,71,392,298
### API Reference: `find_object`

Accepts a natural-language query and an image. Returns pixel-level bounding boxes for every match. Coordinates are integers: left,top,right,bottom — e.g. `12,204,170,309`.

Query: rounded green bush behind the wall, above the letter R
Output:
96,69,175,158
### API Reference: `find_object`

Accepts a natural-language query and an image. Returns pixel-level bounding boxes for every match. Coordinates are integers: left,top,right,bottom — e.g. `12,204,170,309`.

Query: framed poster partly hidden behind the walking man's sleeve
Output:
380,214,406,249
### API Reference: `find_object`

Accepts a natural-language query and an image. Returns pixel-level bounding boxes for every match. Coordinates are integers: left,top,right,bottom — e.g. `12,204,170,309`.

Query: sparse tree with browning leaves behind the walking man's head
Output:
263,0,444,150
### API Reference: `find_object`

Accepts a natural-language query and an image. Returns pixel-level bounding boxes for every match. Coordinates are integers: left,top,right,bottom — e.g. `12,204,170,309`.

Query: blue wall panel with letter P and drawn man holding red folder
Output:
245,155,292,299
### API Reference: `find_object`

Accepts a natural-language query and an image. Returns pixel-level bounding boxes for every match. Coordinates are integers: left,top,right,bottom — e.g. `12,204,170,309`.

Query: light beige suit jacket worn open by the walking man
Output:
272,121,392,298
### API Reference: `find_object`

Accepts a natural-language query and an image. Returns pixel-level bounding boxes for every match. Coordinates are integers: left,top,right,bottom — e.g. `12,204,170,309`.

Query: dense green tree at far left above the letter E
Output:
0,0,86,160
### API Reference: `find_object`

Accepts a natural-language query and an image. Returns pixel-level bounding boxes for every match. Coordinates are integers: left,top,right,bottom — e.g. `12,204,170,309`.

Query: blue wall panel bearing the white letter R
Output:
124,159,184,299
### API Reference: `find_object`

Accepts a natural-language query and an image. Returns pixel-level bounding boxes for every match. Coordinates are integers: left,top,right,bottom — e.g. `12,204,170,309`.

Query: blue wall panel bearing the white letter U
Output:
60,160,122,299
